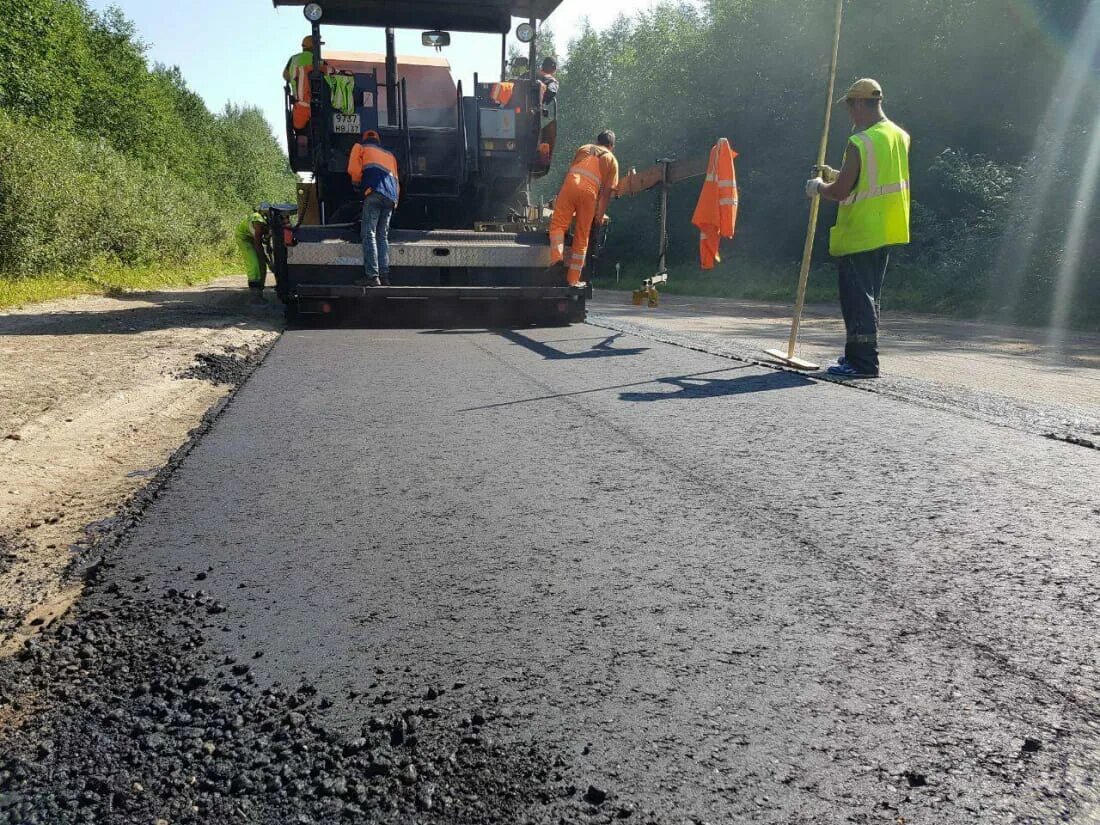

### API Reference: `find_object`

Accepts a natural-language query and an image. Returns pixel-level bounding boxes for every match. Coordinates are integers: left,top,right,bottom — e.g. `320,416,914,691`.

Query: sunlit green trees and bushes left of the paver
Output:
0,0,295,288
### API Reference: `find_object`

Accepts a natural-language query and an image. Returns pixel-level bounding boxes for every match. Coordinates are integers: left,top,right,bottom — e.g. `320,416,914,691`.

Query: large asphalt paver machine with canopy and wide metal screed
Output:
270,0,591,323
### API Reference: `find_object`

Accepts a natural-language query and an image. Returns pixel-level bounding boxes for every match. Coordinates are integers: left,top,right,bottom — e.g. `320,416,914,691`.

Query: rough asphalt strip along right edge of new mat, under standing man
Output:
587,314,1100,450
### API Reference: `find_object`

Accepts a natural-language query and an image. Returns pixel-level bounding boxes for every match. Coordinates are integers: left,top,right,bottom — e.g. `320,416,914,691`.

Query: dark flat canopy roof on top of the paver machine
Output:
272,0,561,34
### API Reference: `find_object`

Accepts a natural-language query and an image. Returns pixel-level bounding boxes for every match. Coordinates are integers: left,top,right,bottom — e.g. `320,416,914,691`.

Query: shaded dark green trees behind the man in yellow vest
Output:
554,0,1100,323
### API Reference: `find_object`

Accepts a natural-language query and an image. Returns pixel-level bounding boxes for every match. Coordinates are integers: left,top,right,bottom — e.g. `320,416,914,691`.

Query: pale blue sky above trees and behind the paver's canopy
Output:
90,0,655,147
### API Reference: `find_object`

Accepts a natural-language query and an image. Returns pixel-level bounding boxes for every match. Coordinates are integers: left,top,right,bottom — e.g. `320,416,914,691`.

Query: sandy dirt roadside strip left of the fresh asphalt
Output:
0,277,282,656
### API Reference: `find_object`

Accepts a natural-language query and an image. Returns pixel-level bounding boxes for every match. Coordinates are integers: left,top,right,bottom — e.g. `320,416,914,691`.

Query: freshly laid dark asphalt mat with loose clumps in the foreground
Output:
0,326,1100,825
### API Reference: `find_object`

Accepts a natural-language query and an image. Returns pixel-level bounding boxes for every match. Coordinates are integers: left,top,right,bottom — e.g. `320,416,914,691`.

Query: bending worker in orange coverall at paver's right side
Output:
550,143,618,286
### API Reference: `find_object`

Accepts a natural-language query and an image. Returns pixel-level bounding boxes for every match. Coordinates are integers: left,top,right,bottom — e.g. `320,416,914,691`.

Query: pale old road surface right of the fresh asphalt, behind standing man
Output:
593,290,1100,444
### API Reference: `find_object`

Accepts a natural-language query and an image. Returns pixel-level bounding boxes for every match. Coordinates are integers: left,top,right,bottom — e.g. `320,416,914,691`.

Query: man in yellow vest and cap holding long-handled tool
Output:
806,78,910,378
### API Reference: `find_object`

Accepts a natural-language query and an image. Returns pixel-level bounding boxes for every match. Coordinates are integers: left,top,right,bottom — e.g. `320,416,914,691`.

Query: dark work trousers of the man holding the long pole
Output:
836,248,890,375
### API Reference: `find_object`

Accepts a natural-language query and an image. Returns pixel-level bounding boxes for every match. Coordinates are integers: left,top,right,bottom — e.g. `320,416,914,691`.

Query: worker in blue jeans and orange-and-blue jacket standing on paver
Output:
348,129,400,286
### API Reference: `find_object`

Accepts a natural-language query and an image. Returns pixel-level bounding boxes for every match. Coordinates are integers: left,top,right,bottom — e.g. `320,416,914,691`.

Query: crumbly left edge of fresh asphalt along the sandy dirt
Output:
63,331,283,584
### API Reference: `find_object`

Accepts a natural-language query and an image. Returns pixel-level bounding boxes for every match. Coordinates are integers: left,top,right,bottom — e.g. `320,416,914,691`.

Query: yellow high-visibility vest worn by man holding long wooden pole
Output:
829,120,910,257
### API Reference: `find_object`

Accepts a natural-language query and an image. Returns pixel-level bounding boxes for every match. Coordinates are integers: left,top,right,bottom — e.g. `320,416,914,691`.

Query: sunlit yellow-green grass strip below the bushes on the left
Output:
0,253,234,309
